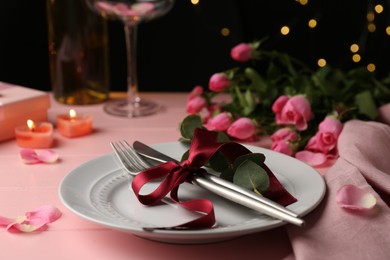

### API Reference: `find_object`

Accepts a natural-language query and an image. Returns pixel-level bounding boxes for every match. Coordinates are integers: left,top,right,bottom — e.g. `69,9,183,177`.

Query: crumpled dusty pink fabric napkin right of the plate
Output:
287,120,390,260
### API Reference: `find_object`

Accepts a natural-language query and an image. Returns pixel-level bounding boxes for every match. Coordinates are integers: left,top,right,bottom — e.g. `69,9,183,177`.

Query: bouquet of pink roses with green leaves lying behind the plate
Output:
180,37,390,166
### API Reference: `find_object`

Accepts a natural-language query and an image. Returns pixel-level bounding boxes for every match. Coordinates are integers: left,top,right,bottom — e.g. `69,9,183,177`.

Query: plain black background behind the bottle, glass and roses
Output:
0,0,390,91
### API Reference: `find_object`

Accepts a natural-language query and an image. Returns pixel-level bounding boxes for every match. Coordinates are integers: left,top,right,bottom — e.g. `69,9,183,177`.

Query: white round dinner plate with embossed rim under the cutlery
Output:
59,142,326,244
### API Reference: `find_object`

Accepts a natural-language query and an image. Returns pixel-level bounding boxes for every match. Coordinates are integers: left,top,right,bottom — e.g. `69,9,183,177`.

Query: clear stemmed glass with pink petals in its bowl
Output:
86,0,174,117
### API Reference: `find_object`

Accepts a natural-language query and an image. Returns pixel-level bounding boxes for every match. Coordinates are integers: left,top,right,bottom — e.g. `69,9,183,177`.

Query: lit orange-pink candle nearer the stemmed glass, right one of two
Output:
57,109,92,137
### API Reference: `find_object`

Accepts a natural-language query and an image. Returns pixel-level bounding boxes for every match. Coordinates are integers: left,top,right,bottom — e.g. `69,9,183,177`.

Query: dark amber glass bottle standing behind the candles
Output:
46,0,109,105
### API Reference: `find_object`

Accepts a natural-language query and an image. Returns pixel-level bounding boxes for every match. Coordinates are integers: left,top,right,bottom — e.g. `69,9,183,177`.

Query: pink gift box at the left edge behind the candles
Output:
0,82,50,142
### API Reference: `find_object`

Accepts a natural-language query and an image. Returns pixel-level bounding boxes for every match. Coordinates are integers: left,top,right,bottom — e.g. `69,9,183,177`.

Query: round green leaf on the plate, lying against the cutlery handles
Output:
233,160,270,193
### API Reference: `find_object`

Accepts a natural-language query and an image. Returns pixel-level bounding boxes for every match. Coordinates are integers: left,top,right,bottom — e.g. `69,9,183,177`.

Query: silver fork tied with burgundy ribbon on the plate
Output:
110,140,305,226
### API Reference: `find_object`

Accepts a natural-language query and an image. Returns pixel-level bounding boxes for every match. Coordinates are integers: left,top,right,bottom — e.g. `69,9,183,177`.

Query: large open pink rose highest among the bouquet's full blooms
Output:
272,95,313,131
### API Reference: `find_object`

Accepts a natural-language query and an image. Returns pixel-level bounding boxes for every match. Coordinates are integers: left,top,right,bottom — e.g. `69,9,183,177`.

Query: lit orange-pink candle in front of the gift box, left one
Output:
15,119,53,149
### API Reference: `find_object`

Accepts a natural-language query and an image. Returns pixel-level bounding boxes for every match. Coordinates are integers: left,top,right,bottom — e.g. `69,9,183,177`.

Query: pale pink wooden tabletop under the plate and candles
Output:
0,93,291,260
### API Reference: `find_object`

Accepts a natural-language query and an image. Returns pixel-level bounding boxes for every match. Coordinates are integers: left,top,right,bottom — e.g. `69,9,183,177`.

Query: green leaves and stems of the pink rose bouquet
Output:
181,39,390,147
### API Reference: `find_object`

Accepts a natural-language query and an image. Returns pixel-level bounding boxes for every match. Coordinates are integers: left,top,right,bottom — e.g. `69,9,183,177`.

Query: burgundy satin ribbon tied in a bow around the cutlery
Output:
132,128,296,229
